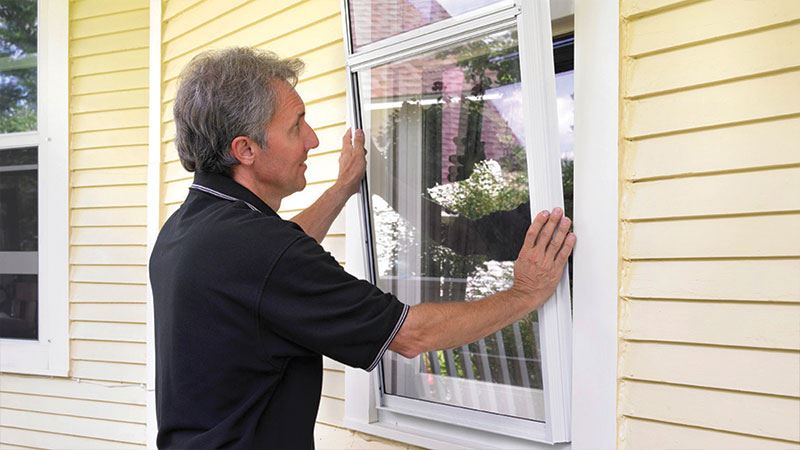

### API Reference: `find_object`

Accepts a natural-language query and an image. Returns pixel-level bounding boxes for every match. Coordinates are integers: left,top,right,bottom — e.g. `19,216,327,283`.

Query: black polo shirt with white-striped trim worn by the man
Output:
150,174,408,449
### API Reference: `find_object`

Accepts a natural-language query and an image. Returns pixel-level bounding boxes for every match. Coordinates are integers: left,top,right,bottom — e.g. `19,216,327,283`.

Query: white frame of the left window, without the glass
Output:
0,0,69,376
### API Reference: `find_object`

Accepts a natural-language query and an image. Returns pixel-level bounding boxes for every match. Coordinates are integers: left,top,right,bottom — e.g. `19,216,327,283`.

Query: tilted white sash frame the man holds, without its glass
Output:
342,1,571,443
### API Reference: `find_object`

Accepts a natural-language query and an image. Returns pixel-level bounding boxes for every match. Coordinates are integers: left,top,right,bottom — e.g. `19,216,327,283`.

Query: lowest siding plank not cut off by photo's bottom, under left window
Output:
0,409,146,444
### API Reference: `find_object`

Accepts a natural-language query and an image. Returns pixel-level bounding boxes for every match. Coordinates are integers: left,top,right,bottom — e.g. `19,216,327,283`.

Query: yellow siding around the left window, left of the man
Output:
0,0,149,449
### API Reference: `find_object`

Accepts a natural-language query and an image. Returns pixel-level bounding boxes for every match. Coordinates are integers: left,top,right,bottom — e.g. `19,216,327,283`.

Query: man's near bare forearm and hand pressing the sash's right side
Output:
389,208,576,358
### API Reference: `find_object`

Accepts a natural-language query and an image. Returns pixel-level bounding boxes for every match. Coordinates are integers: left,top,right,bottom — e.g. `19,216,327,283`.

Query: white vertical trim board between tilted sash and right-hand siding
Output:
572,1,619,449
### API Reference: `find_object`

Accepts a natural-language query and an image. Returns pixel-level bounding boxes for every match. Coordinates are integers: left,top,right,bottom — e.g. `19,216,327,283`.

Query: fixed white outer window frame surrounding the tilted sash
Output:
343,2,619,449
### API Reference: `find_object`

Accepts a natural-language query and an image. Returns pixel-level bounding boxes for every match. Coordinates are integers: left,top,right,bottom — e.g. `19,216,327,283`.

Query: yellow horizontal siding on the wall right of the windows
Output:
618,0,800,449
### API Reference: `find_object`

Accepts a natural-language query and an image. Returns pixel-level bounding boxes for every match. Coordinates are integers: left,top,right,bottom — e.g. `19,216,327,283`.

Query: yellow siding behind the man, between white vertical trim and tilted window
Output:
160,0,402,448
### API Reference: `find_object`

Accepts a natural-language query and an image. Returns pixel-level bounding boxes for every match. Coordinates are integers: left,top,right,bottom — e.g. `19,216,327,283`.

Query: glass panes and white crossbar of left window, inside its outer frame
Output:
0,1,39,339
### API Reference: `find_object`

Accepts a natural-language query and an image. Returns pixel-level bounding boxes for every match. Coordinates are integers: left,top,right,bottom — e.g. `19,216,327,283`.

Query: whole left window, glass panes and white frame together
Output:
0,0,69,375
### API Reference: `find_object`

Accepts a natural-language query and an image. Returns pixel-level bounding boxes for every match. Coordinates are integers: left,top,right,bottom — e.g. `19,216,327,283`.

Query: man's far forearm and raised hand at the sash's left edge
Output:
291,130,367,242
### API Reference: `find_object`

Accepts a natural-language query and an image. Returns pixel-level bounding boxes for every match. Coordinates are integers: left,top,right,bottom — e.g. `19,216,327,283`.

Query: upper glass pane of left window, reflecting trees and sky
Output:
0,0,37,133
